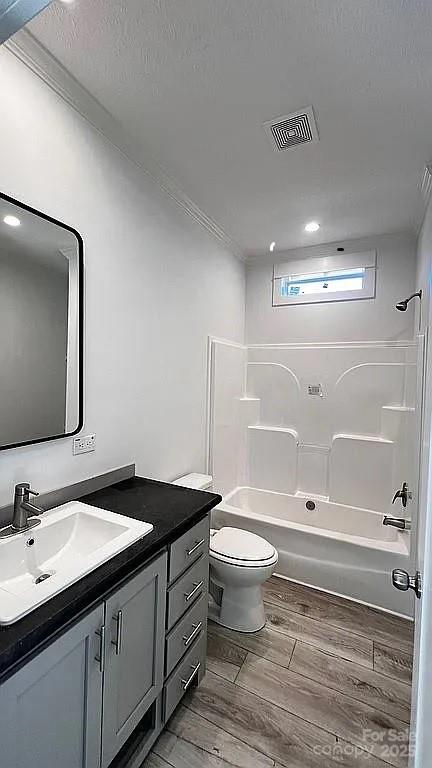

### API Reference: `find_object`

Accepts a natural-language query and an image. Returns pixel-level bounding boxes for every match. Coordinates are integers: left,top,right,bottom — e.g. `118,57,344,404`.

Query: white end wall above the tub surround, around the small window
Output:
246,234,416,344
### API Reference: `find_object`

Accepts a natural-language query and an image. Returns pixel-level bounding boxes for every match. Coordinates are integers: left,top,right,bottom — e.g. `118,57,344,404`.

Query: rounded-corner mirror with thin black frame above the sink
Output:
0,195,83,449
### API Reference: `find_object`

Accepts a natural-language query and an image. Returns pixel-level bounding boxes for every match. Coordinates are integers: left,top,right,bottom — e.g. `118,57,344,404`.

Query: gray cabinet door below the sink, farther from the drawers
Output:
0,606,104,768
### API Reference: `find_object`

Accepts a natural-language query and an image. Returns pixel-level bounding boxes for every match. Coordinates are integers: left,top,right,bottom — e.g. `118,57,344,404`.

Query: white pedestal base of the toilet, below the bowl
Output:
209,586,266,633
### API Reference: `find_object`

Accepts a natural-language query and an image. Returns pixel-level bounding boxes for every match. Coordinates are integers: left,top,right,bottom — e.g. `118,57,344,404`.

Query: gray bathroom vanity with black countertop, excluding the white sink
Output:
0,477,220,768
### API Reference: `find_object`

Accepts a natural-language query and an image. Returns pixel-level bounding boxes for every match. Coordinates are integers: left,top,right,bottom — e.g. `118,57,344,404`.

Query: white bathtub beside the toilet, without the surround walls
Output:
212,487,413,616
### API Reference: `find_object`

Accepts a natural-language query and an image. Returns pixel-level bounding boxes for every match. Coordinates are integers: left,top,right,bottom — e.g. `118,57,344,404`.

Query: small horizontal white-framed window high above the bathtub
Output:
273,250,376,306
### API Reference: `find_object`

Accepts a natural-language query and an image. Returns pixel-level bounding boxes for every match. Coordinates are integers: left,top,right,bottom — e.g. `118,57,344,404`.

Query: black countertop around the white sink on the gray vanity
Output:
0,477,221,682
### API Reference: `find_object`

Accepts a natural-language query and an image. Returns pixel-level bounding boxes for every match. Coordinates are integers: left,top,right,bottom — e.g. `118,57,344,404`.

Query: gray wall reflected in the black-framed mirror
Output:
0,249,68,445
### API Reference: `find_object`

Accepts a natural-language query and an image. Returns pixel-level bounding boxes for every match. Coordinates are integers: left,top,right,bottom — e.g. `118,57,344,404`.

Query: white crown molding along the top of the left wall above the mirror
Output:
4,29,245,261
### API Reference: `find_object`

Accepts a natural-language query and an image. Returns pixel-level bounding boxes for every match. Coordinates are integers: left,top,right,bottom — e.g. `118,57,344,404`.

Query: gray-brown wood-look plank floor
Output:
143,577,413,768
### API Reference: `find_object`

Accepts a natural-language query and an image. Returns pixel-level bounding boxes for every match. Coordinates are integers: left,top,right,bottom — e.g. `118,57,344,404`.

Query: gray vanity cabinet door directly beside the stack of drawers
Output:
102,554,167,768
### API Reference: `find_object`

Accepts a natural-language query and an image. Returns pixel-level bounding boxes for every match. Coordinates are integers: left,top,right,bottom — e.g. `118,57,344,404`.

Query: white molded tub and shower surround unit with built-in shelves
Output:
208,336,423,613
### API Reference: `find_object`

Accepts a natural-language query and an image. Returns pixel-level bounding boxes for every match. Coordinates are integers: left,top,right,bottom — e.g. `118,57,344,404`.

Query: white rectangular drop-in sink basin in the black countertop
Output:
0,501,153,624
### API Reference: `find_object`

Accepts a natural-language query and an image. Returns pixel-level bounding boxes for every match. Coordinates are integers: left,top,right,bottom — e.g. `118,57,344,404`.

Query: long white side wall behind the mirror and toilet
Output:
0,50,244,504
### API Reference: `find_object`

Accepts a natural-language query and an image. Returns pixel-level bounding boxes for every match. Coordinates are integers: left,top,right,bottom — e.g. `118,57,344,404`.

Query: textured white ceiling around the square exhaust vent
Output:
28,0,432,254
